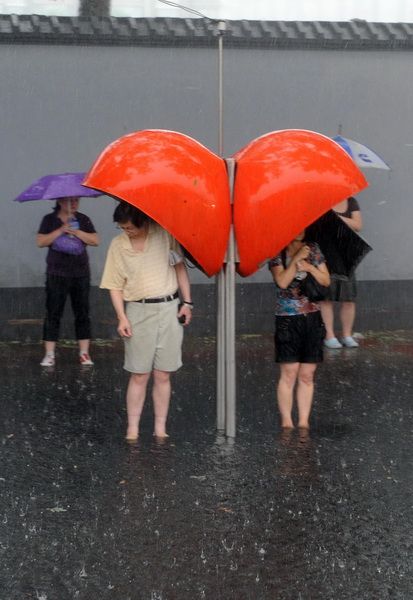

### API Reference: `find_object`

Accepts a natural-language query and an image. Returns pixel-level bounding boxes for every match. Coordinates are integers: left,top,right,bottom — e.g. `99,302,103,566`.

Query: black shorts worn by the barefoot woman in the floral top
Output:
274,311,325,363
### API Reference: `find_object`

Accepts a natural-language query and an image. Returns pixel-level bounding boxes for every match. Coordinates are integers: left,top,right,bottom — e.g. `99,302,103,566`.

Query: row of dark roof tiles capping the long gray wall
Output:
0,15,413,50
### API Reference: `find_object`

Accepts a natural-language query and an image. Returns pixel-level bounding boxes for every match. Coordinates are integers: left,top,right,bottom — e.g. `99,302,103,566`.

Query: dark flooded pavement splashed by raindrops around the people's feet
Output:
0,332,413,600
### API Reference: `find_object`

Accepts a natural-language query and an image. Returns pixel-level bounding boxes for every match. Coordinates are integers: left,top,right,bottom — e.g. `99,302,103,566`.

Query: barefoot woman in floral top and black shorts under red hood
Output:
269,232,330,429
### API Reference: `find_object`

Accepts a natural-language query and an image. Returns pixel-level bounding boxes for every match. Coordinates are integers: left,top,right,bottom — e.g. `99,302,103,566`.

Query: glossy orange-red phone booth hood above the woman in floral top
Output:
233,129,368,277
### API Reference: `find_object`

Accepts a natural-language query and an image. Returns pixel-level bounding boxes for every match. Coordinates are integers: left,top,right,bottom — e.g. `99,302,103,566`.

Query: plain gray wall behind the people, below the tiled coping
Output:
0,45,413,338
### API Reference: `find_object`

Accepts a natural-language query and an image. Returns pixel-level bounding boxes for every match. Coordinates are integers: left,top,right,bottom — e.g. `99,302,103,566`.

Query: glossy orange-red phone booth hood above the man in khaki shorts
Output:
83,129,231,276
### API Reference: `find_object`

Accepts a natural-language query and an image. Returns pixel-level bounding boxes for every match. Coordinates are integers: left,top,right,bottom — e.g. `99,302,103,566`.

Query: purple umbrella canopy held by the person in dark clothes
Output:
15,173,102,202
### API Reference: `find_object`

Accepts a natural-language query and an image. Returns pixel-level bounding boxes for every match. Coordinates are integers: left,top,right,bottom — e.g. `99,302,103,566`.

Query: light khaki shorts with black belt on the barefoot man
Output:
123,299,184,373
